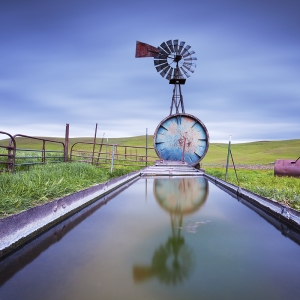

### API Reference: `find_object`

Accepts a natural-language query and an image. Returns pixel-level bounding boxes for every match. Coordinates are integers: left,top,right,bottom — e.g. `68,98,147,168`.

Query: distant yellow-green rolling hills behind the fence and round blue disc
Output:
0,135,300,164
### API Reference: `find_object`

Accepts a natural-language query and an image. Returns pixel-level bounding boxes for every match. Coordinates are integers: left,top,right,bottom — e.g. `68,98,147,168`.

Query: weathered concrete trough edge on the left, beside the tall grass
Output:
0,171,141,257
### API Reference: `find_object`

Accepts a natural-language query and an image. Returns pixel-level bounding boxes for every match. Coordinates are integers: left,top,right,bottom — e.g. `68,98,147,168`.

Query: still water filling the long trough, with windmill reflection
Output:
0,177,300,300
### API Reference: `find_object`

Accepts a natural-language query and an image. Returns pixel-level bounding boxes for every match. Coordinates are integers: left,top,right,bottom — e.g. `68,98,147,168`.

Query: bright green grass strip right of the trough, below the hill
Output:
206,168,300,210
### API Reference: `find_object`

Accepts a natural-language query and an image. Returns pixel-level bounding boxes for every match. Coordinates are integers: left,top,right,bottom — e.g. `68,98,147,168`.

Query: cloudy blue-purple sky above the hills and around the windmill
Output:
0,0,300,142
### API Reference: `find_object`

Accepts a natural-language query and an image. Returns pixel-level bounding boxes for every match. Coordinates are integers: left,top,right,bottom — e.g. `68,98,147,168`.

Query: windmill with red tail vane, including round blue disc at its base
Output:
135,40,209,166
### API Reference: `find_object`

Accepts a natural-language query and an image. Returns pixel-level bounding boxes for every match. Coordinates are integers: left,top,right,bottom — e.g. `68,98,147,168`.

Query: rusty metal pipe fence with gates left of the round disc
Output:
0,129,158,172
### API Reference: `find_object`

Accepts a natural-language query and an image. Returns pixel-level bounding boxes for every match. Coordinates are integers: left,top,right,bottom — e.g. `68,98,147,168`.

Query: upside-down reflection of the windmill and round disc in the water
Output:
133,177,208,285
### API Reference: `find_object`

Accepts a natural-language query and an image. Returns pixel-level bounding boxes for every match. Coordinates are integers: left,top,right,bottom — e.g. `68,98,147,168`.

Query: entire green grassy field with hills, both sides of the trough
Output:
0,136,300,217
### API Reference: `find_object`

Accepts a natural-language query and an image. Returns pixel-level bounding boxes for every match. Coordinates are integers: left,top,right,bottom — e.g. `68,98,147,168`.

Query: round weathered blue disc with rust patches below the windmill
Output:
154,114,209,166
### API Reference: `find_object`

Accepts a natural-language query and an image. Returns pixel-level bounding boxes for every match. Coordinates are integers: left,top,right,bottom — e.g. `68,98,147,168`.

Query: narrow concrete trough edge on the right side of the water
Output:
204,173,300,229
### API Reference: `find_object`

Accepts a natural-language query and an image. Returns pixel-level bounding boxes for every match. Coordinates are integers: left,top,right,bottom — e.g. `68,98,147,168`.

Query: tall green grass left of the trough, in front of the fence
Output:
0,162,142,218
